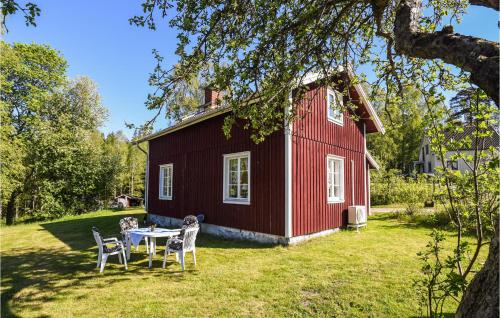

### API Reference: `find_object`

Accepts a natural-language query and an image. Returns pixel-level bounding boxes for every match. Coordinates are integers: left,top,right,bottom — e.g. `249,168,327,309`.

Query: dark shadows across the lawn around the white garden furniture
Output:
1,214,269,317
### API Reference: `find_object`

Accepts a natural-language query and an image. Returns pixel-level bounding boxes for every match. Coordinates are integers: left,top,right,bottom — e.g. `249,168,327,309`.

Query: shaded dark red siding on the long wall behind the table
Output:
148,115,285,235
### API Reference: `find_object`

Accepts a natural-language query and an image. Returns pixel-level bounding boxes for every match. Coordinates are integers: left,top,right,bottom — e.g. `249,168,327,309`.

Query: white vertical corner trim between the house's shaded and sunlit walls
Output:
285,92,293,238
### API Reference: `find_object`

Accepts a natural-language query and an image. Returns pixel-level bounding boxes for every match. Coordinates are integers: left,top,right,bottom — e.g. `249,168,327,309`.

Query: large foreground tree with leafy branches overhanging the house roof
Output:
130,0,500,316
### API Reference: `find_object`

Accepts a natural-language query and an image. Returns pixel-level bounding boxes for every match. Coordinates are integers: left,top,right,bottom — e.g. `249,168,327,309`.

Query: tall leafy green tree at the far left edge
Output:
0,42,67,224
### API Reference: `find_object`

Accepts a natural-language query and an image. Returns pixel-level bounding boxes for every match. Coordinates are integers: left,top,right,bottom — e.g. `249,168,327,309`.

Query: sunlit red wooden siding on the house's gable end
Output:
292,87,366,236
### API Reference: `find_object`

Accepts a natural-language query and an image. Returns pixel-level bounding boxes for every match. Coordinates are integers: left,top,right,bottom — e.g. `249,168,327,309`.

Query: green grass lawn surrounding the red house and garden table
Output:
0,210,484,317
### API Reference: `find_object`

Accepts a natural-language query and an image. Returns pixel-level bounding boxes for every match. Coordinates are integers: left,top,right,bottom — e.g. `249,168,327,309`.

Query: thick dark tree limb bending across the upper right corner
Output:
394,0,500,106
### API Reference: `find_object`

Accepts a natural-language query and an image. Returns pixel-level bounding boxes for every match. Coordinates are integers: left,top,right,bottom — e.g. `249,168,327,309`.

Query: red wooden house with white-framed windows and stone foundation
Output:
141,75,384,244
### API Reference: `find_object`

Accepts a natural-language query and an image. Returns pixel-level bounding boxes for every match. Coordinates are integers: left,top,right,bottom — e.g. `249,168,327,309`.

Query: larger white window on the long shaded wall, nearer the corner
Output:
223,151,250,204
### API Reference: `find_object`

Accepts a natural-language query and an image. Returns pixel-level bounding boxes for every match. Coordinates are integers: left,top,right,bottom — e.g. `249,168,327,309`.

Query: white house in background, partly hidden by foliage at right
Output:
413,126,499,174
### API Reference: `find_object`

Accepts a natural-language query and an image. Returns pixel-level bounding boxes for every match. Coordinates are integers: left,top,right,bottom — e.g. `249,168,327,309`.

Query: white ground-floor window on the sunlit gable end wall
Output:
326,155,344,203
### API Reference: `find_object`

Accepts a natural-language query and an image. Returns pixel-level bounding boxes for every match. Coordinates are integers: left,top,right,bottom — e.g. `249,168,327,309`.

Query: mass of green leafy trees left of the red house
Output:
0,42,145,224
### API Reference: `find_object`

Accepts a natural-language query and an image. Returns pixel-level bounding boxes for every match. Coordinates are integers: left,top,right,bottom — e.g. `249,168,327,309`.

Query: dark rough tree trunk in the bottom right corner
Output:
455,224,500,318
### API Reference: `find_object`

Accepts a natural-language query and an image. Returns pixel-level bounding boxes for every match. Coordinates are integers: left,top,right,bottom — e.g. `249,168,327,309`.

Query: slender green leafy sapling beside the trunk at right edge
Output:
419,87,500,317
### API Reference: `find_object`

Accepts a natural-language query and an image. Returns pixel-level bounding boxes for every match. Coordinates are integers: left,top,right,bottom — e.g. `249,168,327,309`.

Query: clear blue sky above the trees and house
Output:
5,0,499,136
